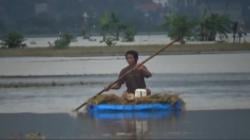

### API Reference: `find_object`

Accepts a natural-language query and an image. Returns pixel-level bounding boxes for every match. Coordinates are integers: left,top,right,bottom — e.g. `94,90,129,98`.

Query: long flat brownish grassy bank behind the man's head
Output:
0,43,250,58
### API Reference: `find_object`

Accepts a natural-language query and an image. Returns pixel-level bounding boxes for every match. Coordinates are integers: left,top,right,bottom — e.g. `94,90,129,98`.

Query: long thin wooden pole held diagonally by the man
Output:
74,39,179,111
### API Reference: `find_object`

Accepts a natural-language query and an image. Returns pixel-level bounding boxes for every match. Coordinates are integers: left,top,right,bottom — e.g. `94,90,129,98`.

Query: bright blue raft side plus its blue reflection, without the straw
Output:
87,101,183,120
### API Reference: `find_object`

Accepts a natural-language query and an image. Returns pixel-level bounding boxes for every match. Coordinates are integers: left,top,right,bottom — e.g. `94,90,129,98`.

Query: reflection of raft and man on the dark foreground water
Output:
78,111,183,139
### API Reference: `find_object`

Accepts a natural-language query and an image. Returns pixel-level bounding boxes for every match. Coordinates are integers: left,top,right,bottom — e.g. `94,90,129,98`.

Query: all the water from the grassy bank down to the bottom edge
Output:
0,53,250,139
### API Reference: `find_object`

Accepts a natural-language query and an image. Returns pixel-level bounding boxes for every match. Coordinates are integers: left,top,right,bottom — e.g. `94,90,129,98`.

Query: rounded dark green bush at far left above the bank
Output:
3,32,25,48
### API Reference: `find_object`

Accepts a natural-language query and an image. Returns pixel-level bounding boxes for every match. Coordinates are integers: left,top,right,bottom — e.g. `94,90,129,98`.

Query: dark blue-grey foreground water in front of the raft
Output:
0,110,250,139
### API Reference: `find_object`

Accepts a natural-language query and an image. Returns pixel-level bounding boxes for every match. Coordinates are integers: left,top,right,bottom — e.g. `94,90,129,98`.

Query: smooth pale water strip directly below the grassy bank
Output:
0,52,250,76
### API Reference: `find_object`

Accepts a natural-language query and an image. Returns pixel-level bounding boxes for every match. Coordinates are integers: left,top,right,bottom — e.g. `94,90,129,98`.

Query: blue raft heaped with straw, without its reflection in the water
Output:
87,94,184,112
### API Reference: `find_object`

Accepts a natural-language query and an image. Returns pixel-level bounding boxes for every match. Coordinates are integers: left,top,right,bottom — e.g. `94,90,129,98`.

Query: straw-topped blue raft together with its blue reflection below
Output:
87,92,185,119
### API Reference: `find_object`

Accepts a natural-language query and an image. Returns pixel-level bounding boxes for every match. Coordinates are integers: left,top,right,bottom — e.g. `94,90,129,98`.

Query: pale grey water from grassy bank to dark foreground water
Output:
0,53,250,113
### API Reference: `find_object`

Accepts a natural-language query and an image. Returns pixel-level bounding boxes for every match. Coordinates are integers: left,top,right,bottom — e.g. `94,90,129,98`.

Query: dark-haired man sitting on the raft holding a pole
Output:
106,50,152,96
